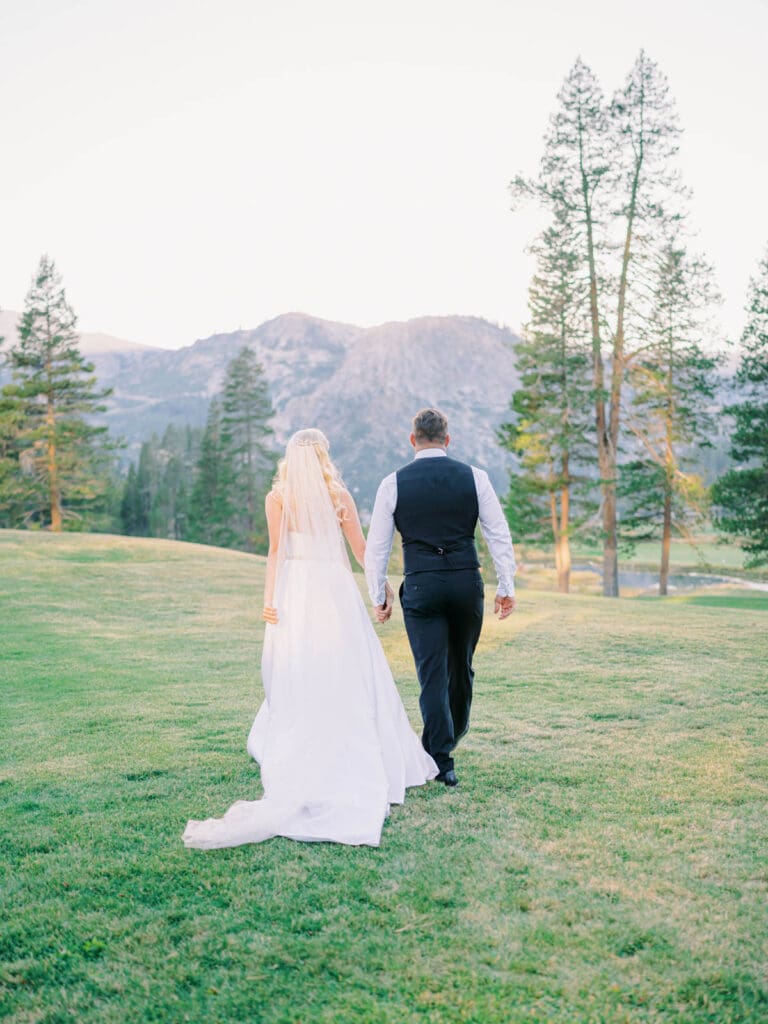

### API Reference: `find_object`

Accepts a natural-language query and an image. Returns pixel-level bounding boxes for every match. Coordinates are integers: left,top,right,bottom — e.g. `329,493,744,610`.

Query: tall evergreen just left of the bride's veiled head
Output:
221,348,276,551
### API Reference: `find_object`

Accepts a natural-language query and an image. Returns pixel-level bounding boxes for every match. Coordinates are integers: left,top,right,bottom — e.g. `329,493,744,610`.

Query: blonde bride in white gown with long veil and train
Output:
182,428,437,850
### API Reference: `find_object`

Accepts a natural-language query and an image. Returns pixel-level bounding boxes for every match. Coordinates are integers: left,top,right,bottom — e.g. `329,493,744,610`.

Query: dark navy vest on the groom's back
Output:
394,456,480,575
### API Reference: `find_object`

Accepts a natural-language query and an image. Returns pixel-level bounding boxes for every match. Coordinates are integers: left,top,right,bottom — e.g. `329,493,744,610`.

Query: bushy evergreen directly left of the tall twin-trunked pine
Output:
499,207,594,593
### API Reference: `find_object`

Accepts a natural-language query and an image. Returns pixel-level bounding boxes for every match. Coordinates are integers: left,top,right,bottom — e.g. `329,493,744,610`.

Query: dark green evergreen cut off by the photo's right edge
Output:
714,250,768,566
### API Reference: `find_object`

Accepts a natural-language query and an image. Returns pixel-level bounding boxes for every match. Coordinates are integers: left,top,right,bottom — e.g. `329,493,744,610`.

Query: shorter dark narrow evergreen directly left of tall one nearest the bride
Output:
188,398,237,548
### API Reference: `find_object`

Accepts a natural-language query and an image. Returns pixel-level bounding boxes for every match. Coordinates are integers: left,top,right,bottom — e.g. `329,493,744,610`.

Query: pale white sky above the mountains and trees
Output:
0,0,768,347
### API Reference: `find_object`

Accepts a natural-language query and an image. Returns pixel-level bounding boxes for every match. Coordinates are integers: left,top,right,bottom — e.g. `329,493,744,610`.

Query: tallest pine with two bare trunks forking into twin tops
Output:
511,51,680,597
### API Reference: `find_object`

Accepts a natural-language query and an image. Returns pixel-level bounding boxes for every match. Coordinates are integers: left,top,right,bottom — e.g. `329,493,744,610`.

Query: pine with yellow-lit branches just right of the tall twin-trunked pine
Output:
620,234,720,595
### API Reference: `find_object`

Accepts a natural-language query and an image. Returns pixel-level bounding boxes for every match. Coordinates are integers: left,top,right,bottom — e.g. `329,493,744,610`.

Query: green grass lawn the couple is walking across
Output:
0,531,768,1024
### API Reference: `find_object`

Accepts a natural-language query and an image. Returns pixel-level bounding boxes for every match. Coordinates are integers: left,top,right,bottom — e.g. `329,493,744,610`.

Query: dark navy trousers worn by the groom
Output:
400,569,483,772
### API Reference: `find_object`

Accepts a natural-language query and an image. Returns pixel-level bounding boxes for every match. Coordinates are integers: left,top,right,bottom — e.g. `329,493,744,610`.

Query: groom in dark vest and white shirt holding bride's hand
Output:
366,409,515,786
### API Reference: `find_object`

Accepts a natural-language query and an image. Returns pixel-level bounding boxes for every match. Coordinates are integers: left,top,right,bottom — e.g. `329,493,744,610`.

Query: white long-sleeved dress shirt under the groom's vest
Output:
366,449,516,605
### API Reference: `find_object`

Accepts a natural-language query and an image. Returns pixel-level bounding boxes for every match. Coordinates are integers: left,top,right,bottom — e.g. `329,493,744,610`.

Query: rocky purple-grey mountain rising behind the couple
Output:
0,313,518,511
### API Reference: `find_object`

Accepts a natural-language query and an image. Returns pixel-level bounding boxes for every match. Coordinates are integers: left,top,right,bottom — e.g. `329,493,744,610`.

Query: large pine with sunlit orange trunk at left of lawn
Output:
9,256,111,531
